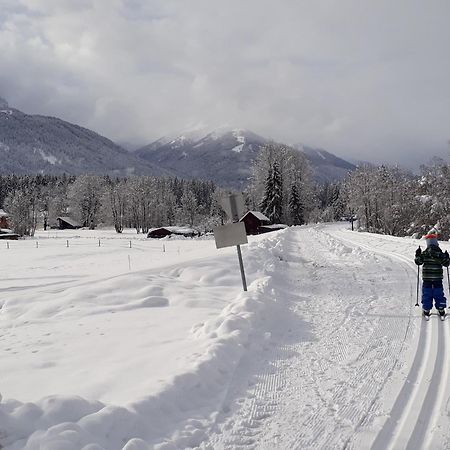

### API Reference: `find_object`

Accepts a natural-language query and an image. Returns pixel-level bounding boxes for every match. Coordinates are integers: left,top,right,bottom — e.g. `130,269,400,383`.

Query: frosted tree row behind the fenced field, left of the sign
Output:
0,175,224,236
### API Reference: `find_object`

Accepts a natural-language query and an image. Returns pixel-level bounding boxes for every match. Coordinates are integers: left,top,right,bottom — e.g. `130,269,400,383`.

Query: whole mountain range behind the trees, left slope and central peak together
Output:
0,98,354,186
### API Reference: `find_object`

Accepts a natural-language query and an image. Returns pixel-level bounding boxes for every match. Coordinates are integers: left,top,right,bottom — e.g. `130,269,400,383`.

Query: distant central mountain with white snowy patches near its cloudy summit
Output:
136,128,355,189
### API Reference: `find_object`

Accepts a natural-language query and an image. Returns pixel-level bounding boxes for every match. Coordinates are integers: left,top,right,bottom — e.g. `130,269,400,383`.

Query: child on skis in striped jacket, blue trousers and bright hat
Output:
414,228,450,319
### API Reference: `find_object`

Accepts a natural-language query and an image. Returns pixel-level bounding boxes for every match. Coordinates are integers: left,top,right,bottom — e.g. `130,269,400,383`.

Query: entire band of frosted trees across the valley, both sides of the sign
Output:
0,143,450,238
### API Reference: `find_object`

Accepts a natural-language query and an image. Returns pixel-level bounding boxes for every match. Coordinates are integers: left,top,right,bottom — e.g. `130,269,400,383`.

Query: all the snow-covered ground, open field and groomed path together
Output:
0,224,450,450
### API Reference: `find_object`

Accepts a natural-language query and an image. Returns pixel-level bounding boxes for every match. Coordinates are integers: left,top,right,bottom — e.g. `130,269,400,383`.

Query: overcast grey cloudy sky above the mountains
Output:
0,0,450,166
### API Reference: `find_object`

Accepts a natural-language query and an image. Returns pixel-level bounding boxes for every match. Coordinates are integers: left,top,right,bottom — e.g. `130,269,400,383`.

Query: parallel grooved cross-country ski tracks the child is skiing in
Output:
330,229,450,450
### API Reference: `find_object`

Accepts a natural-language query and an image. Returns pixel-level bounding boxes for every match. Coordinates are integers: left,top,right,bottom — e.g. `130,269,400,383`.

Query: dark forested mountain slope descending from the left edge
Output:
0,98,169,175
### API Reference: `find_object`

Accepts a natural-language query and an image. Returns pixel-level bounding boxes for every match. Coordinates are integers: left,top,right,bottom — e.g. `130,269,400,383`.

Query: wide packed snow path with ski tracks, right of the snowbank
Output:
202,226,450,449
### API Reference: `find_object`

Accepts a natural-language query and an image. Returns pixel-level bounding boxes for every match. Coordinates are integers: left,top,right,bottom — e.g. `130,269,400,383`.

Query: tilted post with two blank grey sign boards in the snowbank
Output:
214,194,248,291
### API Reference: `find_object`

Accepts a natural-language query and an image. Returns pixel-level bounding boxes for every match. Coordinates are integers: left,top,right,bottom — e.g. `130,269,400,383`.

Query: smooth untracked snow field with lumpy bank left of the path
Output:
0,233,284,450
